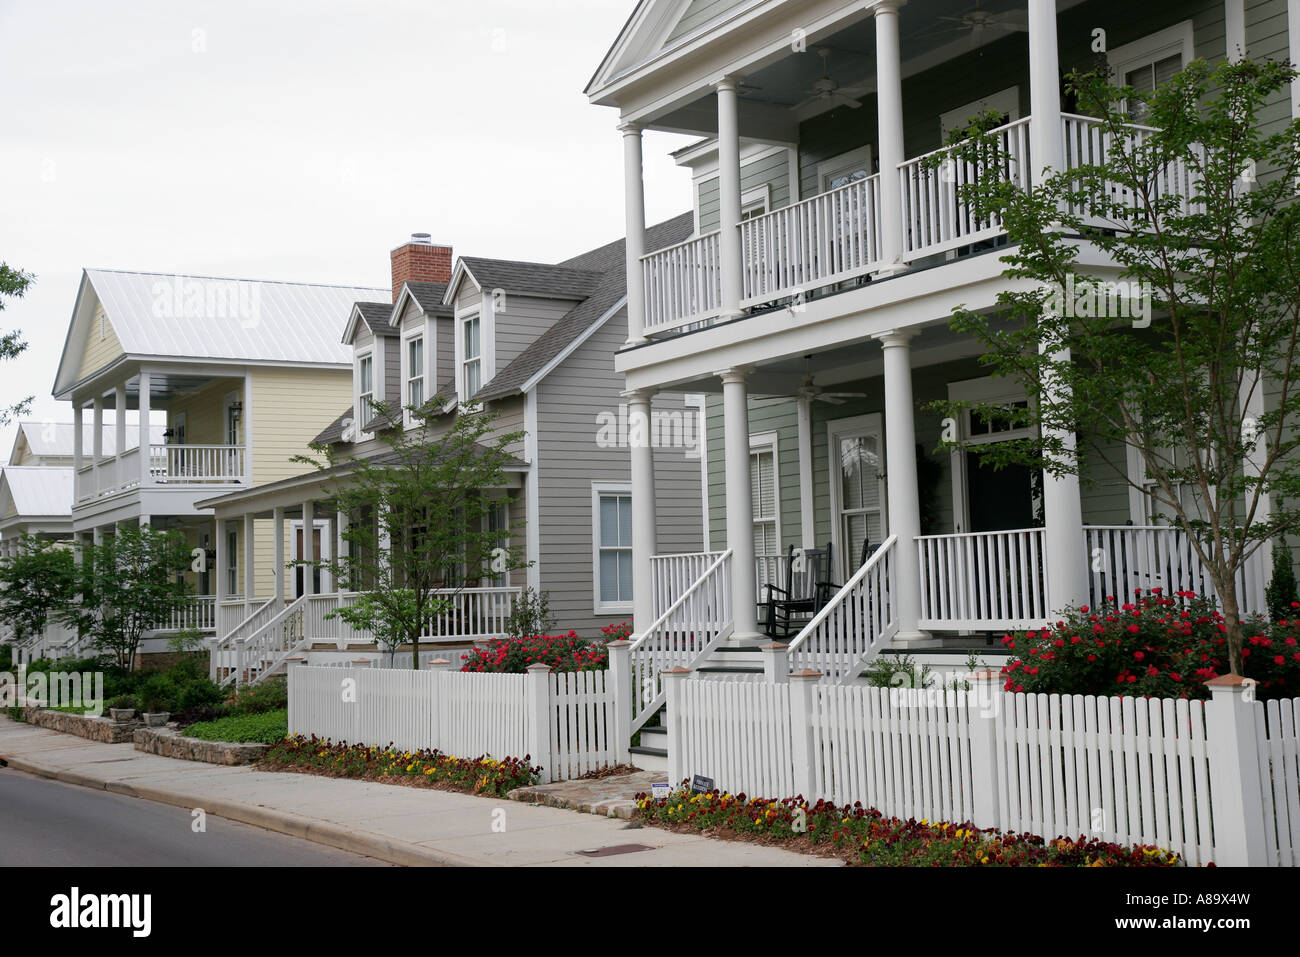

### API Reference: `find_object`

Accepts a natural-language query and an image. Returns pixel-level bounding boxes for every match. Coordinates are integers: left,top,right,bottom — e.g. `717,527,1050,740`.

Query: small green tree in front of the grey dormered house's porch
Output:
302,397,524,668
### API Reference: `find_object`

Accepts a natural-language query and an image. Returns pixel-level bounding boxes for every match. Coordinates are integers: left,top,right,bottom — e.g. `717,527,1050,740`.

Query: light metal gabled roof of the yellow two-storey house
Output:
55,269,390,397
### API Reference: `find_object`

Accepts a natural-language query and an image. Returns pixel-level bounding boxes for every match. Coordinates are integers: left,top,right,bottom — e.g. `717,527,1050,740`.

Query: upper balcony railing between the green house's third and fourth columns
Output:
898,117,1031,259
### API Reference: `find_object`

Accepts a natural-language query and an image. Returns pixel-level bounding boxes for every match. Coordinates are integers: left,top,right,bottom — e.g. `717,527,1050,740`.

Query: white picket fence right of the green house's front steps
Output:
666,674,1300,866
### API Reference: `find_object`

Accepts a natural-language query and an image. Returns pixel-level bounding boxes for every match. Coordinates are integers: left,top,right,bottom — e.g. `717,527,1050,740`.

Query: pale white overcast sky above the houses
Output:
0,0,690,426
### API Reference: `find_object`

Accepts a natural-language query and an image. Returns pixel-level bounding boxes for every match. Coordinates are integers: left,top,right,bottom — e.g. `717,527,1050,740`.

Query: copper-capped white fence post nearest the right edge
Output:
1205,675,1274,867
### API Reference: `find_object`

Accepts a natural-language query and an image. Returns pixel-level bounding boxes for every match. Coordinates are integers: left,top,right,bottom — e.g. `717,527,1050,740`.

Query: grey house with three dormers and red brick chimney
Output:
200,228,703,681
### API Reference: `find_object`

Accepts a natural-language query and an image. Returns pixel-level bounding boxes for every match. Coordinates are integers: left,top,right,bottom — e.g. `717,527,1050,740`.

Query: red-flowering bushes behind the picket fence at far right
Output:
1002,588,1300,698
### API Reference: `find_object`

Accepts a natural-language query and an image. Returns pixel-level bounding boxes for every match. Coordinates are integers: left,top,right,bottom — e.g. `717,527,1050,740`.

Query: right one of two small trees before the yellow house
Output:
62,525,190,671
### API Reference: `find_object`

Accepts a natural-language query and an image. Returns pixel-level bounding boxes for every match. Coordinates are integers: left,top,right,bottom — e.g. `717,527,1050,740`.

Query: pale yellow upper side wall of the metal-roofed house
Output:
245,369,352,485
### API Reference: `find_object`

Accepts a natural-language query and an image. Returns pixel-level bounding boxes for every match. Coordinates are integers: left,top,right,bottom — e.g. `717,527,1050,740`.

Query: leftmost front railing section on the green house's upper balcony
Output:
641,231,722,333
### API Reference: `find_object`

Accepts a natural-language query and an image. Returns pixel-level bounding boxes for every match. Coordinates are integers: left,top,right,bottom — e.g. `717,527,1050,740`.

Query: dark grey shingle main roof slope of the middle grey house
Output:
475,213,694,400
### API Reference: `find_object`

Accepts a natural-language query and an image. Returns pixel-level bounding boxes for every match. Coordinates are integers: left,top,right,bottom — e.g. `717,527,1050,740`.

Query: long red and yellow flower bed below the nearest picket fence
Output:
637,788,1180,867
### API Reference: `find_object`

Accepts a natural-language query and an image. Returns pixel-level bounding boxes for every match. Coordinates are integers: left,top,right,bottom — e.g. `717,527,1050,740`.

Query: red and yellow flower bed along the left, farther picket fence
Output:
259,735,541,797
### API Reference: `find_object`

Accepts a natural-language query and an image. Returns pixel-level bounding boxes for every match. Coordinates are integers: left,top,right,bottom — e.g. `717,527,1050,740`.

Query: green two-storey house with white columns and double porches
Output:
586,0,1279,729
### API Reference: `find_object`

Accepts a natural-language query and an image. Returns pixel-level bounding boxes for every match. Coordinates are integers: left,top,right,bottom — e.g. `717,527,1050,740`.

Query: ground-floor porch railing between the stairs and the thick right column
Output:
917,528,1052,629
